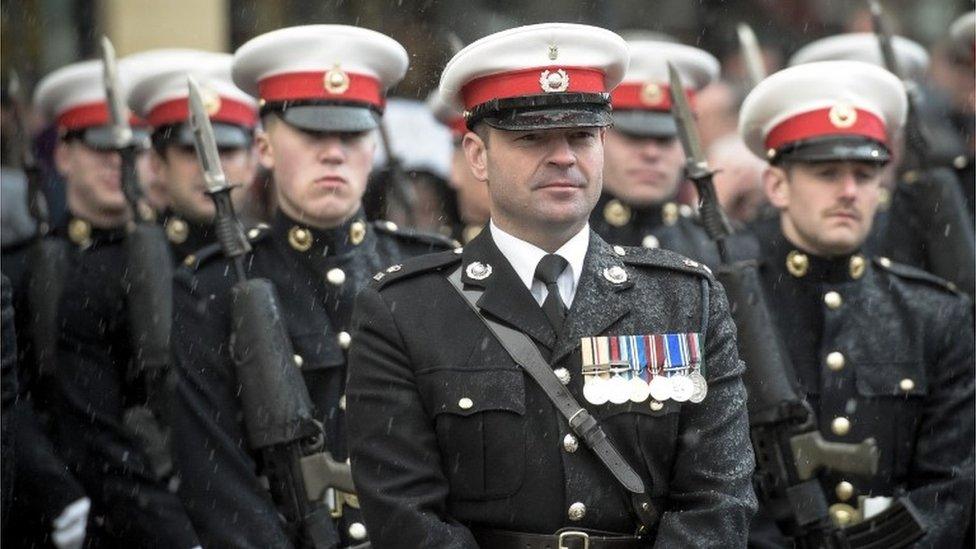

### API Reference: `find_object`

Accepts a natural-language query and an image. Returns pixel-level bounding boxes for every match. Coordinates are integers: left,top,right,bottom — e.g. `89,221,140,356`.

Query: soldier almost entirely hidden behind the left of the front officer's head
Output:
427,90,489,244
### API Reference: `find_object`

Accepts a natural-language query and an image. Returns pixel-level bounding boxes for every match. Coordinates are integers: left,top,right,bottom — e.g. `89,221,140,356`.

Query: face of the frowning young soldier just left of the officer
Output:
257,115,376,228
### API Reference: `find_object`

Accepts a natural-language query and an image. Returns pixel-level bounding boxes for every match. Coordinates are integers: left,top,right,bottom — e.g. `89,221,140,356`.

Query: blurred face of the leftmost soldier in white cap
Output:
55,139,128,216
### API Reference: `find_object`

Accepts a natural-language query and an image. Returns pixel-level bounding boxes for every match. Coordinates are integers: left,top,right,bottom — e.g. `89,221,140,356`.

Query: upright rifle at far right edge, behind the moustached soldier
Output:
869,0,976,296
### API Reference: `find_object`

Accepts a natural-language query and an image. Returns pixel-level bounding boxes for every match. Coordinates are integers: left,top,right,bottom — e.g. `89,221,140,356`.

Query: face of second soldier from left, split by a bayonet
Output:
152,145,257,223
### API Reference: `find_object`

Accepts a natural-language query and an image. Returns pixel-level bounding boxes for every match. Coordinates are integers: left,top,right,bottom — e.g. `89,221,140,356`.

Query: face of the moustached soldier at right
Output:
763,161,882,257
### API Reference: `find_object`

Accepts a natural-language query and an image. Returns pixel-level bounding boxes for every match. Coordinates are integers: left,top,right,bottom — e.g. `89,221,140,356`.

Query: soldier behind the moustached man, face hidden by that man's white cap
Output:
790,33,976,296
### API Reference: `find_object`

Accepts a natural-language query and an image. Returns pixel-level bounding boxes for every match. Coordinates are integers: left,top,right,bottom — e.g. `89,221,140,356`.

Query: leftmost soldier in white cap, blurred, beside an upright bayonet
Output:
24,56,197,548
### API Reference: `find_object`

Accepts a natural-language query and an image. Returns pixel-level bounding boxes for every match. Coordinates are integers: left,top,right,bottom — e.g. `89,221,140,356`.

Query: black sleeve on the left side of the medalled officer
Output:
346,288,477,548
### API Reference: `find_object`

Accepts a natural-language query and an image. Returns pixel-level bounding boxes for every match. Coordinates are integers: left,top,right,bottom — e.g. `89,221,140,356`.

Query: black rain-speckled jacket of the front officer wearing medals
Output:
347,231,755,549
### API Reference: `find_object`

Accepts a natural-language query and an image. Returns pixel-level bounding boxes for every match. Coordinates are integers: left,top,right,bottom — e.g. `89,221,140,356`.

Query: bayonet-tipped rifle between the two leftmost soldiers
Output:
102,36,173,478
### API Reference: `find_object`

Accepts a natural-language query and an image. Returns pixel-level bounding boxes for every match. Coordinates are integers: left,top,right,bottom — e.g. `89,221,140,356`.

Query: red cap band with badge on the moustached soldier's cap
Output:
766,106,888,149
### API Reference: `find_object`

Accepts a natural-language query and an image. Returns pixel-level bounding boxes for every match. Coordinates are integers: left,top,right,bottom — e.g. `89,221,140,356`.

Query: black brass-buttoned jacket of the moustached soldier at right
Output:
748,222,976,548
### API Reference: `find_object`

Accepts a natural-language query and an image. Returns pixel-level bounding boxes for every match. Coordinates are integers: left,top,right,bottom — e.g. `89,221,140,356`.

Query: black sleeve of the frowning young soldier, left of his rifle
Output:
166,276,290,548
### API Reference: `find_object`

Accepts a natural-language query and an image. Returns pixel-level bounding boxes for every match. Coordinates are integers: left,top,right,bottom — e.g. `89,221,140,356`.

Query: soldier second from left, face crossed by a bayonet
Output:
128,50,257,263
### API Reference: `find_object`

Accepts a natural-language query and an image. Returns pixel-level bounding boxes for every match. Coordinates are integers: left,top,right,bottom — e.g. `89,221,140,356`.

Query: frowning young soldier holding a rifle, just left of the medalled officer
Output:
168,25,451,547
